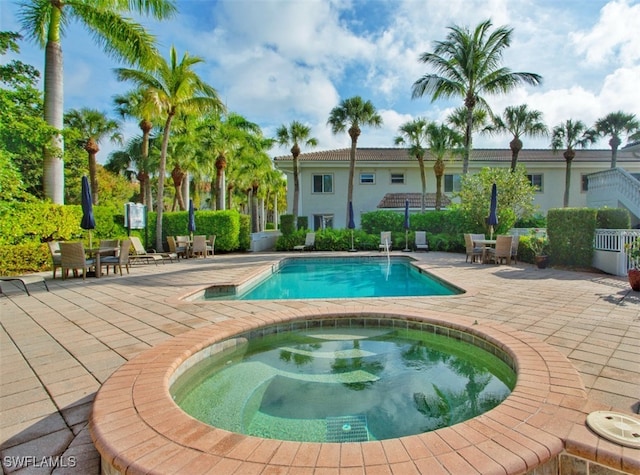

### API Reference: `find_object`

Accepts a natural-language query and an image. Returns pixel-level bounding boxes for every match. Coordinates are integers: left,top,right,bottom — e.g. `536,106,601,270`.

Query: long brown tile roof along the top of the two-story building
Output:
274,148,638,163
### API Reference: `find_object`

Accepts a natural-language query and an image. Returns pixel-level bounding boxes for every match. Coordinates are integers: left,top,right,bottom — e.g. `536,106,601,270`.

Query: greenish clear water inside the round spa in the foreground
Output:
171,327,516,442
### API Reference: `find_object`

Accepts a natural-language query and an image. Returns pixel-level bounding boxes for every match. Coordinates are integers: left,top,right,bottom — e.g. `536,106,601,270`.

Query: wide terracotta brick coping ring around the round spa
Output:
90,306,640,474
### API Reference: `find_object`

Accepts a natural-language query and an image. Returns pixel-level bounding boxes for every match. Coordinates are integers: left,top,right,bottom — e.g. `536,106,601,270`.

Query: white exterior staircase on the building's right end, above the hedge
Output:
587,168,640,226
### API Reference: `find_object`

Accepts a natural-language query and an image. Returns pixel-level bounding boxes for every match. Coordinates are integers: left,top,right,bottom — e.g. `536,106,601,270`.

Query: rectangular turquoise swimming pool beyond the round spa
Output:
204,256,462,300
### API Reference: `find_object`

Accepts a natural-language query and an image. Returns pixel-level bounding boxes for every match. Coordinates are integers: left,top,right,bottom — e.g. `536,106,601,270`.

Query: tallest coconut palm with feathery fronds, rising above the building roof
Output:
412,20,542,173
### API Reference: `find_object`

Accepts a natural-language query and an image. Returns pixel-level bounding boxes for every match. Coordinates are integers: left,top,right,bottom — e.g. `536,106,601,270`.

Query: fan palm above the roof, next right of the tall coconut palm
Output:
492,104,549,172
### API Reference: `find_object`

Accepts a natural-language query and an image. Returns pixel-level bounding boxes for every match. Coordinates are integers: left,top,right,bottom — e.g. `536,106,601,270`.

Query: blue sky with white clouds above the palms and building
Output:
0,0,640,163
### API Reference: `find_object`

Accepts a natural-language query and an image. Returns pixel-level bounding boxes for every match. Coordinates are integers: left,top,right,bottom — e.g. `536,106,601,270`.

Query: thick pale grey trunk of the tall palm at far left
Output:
42,35,64,204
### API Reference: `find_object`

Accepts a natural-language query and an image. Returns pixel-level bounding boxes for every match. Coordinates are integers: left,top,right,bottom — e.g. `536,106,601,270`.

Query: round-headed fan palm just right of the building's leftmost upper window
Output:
327,96,382,226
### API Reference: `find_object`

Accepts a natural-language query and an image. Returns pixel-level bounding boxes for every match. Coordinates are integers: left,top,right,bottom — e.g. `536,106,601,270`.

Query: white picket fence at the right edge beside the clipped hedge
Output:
592,229,640,276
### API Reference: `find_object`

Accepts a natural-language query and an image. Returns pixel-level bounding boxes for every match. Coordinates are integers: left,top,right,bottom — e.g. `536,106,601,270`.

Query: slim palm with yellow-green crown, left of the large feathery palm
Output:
113,89,161,207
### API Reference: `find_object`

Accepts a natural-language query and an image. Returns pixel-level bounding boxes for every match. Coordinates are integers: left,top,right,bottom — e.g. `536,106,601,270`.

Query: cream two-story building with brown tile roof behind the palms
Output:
274,148,640,230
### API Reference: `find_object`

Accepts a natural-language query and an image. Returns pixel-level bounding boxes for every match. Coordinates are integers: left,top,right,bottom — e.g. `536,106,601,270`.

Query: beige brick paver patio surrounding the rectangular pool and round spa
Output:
0,252,640,474
